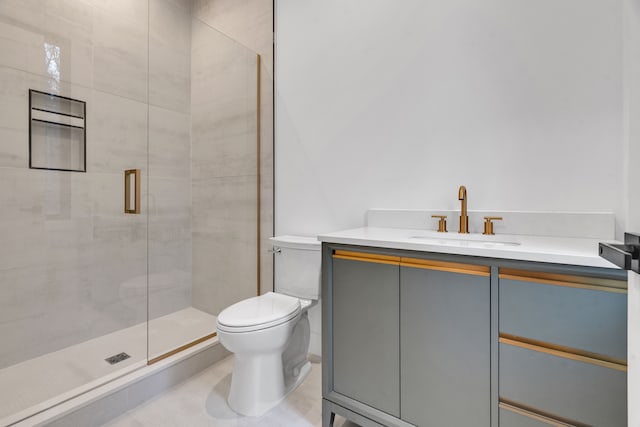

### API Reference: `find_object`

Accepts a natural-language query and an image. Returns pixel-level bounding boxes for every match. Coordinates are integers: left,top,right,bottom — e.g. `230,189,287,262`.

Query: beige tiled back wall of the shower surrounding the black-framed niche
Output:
0,0,191,368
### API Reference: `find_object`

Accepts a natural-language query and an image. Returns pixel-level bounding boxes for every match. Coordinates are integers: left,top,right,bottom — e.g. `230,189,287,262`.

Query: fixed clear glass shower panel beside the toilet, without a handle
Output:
149,15,259,363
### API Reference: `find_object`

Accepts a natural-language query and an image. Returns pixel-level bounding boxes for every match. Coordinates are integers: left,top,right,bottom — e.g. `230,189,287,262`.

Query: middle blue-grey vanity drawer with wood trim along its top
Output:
499,338,627,427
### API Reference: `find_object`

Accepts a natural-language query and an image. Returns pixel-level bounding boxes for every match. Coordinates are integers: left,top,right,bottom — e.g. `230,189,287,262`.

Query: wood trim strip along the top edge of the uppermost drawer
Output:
498,268,627,294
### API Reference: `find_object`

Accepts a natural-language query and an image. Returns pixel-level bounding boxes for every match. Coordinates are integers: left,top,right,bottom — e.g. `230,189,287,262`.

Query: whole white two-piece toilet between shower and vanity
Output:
216,236,321,417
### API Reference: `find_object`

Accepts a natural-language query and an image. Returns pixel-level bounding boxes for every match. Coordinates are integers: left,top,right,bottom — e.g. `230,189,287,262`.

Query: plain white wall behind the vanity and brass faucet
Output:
275,0,625,234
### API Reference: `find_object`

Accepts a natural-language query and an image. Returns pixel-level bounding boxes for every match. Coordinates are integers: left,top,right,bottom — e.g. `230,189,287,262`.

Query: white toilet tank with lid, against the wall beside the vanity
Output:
269,236,322,300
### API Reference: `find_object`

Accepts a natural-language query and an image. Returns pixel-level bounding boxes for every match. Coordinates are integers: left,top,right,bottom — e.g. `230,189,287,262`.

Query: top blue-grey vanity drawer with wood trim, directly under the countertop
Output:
499,269,627,363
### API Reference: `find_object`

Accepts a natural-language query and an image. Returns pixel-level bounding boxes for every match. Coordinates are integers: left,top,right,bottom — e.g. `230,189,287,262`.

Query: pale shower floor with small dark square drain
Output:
0,307,216,426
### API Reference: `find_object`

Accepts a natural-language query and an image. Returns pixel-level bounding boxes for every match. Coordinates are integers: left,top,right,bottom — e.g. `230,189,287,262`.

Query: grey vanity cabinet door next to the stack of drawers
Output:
400,264,491,427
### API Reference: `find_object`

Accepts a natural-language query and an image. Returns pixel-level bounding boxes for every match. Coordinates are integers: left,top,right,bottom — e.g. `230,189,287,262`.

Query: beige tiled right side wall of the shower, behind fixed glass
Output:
191,19,258,315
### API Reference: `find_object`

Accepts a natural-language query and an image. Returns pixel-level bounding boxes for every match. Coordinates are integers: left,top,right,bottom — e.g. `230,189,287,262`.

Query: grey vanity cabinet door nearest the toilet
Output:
332,254,400,417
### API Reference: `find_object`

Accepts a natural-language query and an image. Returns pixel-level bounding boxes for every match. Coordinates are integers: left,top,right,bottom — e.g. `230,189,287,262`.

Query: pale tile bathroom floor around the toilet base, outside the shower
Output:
105,356,358,427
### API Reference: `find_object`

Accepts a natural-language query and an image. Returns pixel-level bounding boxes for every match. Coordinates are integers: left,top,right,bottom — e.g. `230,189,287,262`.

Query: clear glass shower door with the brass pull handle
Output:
0,0,148,425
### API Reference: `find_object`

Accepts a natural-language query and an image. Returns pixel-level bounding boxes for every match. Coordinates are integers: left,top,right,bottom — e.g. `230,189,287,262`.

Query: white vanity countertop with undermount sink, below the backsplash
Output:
318,227,617,268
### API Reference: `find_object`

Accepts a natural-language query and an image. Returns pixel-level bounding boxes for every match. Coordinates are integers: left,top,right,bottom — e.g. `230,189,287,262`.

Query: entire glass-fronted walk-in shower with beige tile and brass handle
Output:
0,0,261,426
